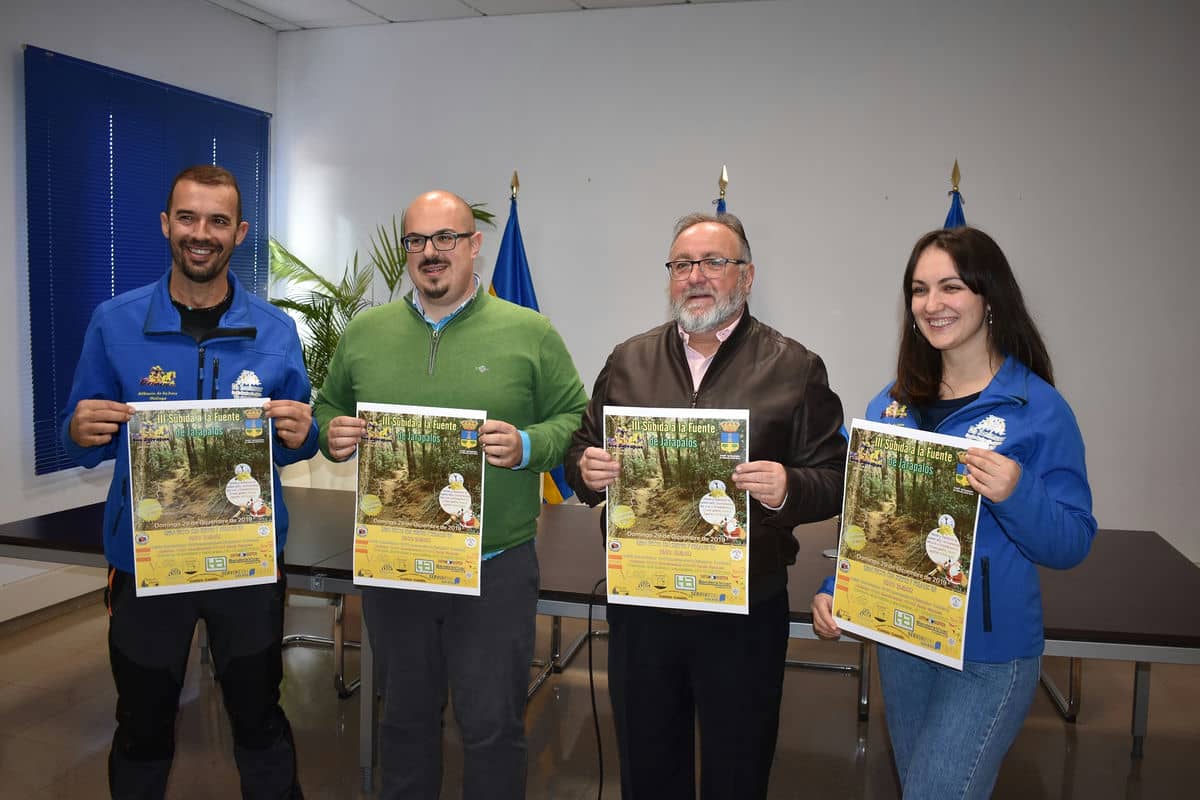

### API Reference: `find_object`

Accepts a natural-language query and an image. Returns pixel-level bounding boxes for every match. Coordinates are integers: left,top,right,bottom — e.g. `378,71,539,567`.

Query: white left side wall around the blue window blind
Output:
0,0,276,532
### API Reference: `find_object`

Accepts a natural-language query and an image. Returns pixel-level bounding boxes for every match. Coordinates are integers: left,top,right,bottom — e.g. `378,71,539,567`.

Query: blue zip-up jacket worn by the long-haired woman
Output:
821,356,1096,663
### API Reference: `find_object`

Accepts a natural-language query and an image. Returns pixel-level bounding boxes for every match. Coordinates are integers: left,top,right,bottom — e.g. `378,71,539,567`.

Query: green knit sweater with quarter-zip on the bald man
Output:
314,289,588,554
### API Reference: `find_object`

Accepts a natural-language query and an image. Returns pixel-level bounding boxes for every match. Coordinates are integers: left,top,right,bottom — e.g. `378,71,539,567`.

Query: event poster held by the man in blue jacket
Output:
126,399,276,596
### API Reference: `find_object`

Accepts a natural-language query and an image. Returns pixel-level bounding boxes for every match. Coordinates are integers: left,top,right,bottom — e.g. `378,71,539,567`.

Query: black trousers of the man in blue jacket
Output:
106,567,302,800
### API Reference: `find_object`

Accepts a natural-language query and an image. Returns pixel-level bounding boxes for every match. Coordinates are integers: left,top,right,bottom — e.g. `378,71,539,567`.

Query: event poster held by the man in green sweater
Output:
354,403,487,595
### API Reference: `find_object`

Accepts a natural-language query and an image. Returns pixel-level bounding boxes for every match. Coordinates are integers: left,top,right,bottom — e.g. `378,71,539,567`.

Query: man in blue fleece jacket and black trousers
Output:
62,166,317,799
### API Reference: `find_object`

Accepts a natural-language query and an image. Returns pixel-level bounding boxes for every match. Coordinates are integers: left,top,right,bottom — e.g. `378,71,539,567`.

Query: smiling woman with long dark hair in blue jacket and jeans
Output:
812,228,1096,800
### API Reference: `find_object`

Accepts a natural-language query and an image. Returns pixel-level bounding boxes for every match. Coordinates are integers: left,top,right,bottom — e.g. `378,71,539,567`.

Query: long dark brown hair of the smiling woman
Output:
890,227,1054,405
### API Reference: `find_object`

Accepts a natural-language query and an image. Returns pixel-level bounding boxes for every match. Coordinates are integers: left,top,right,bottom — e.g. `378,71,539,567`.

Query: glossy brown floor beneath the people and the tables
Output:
0,602,1200,800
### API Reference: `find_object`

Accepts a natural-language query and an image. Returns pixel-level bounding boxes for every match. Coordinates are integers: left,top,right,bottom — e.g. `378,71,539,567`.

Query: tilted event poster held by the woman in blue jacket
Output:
833,420,979,669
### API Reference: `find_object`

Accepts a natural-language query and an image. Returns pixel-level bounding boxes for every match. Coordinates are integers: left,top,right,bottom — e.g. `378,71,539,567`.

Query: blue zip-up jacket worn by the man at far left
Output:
60,270,317,572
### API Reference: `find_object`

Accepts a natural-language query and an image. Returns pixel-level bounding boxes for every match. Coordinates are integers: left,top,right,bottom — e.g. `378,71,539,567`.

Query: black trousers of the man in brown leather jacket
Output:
607,593,788,800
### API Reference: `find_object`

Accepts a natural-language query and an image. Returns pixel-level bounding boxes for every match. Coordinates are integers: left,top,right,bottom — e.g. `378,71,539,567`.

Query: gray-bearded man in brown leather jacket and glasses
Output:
565,213,846,800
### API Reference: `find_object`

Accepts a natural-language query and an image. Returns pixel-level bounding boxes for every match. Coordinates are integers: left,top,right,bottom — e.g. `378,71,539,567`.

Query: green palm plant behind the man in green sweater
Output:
269,203,496,392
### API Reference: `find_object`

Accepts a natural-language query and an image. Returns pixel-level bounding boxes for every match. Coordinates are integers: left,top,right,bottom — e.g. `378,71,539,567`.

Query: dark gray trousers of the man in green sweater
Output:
362,541,538,800
